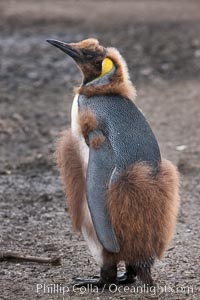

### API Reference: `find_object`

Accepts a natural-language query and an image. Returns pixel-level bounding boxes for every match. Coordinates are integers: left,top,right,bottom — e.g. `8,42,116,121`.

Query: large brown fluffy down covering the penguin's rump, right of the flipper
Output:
104,160,179,263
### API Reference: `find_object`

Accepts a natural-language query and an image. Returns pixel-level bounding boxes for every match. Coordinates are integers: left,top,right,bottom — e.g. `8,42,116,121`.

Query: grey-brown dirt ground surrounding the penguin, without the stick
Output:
0,0,200,300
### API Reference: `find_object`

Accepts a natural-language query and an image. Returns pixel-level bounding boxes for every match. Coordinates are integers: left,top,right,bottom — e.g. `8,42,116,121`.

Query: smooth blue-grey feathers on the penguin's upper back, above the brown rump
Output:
79,95,160,168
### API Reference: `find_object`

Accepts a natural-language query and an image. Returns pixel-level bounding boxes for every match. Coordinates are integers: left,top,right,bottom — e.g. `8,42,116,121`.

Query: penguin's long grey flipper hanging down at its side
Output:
86,130,120,253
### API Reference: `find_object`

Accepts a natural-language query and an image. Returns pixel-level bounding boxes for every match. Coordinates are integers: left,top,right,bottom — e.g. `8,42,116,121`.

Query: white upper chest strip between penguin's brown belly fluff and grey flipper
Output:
71,94,89,171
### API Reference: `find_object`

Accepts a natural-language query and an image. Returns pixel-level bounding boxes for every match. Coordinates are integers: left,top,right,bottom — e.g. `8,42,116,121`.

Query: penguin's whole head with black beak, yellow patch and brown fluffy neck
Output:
47,39,136,100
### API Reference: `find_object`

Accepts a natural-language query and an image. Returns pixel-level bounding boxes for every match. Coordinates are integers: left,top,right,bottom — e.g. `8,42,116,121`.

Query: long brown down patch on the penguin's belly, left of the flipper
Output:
56,129,85,231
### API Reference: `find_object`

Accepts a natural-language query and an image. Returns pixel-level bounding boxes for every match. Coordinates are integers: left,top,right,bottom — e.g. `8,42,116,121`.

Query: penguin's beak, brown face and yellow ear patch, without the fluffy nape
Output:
47,39,109,84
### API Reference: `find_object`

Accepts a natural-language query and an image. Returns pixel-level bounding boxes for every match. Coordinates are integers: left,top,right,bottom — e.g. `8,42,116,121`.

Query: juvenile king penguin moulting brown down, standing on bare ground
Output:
47,39,179,287
